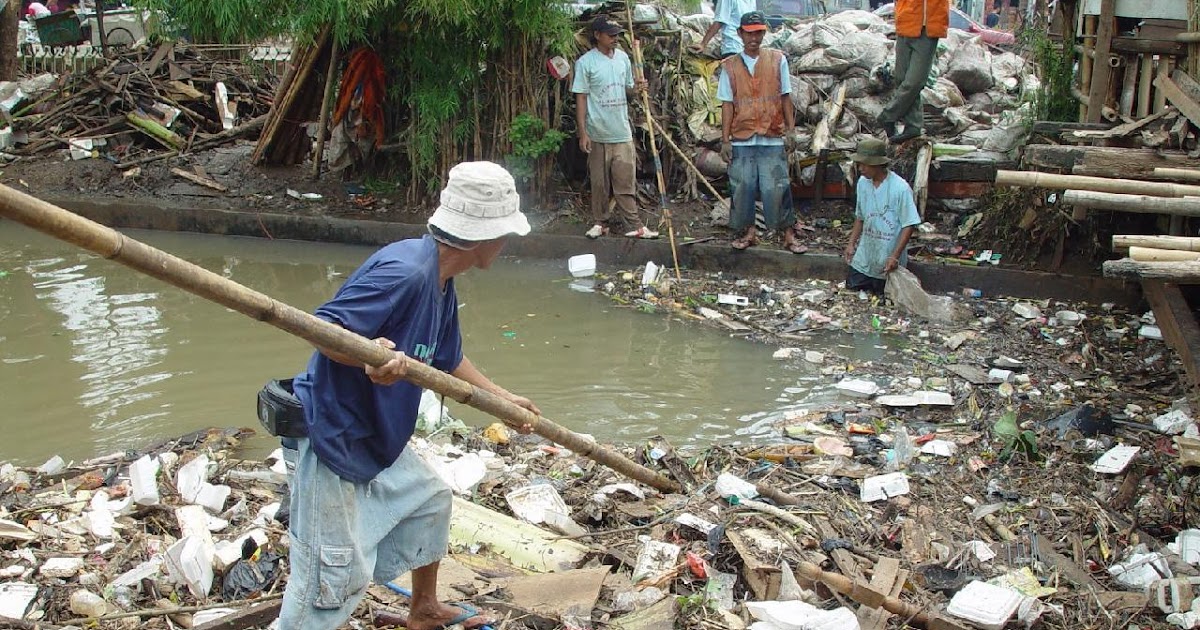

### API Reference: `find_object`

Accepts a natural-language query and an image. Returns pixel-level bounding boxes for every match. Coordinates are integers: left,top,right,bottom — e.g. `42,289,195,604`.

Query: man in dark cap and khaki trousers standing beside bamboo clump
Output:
571,16,659,239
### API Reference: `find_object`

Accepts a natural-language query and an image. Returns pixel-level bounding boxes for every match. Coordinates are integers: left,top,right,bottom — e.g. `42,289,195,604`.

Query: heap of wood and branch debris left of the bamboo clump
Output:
0,42,275,166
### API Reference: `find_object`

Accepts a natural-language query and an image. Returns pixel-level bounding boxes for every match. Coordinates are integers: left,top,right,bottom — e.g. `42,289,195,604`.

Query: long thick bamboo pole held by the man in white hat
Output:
0,186,680,492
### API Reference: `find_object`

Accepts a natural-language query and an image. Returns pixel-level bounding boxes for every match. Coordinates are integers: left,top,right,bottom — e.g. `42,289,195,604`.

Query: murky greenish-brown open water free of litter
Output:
0,220,902,466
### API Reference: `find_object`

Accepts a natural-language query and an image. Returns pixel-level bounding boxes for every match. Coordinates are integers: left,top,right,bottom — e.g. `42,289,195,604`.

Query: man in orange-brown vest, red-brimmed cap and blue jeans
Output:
716,11,806,253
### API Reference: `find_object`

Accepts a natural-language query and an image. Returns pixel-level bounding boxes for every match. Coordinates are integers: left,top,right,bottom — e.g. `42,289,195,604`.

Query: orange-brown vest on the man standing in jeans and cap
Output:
721,48,792,140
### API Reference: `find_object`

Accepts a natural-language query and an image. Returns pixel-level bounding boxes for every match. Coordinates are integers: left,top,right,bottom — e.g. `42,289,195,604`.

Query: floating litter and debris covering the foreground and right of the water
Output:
0,262,1200,630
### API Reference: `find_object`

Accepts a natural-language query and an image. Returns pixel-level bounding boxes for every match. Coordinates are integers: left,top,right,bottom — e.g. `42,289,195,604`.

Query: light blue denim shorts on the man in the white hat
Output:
280,439,451,630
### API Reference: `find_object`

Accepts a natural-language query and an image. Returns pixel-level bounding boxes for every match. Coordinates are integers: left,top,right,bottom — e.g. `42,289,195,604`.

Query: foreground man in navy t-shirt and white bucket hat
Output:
280,162,540,630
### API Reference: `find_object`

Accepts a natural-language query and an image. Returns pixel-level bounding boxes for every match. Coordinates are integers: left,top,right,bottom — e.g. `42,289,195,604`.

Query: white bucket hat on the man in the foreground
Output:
430,162,529,242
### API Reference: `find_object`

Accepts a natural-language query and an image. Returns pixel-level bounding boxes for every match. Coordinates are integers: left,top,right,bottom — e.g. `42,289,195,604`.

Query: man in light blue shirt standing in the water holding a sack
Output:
842,138,920,293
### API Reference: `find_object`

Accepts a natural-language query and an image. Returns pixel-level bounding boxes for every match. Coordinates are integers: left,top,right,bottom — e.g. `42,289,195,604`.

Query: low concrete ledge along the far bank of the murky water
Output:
37,197,1142,307
